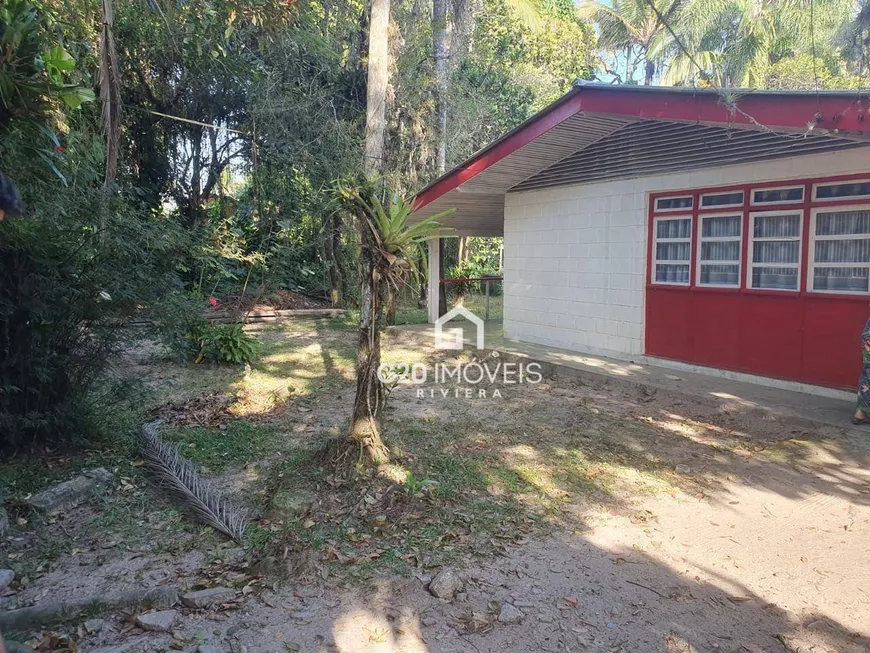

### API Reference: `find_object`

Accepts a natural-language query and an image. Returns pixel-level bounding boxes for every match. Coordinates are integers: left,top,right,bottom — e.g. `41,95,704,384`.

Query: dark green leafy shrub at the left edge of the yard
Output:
0,195,183,450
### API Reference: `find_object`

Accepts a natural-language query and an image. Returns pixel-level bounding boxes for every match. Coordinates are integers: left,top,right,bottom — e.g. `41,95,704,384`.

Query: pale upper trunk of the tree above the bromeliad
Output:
363,0,390,177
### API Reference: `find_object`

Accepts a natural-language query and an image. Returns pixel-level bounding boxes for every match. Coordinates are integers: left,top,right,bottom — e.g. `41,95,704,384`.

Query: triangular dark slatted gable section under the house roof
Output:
511,120,867,191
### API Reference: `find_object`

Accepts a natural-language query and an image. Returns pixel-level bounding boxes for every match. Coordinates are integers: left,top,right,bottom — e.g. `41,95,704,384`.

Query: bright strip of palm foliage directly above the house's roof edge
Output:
581,0,870,89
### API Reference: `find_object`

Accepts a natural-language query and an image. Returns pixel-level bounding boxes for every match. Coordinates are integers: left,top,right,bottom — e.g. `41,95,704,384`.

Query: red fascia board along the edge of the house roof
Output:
414,83,870,209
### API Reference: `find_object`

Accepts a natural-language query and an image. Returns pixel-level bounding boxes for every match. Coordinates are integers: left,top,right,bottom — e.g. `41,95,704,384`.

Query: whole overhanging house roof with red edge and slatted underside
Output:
415,83,870,236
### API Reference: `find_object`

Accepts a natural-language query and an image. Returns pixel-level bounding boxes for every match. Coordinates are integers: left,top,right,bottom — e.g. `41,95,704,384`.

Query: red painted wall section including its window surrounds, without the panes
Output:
645,173,870,389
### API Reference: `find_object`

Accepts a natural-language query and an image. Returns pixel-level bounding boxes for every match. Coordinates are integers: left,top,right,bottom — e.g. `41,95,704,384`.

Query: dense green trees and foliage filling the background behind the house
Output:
0,0,870,446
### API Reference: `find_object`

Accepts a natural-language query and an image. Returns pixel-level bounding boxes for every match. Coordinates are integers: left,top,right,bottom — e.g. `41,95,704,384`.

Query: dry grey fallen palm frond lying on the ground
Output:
139,421,248,542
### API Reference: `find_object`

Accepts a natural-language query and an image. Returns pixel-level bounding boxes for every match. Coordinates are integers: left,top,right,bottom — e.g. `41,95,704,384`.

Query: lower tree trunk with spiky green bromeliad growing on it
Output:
326,180,453,472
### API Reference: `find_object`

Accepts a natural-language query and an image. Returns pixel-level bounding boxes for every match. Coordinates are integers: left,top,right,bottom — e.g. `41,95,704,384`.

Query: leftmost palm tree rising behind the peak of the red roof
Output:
580,0,683,86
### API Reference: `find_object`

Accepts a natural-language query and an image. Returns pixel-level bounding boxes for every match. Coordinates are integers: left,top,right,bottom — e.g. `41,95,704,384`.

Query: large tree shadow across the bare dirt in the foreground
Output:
218,534,870,653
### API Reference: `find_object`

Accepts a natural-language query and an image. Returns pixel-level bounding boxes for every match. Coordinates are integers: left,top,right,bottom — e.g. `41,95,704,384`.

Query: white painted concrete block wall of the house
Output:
504,148,870,358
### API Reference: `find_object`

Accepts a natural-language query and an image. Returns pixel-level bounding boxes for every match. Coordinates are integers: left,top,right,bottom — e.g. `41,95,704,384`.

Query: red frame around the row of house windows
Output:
646,172,870,302
